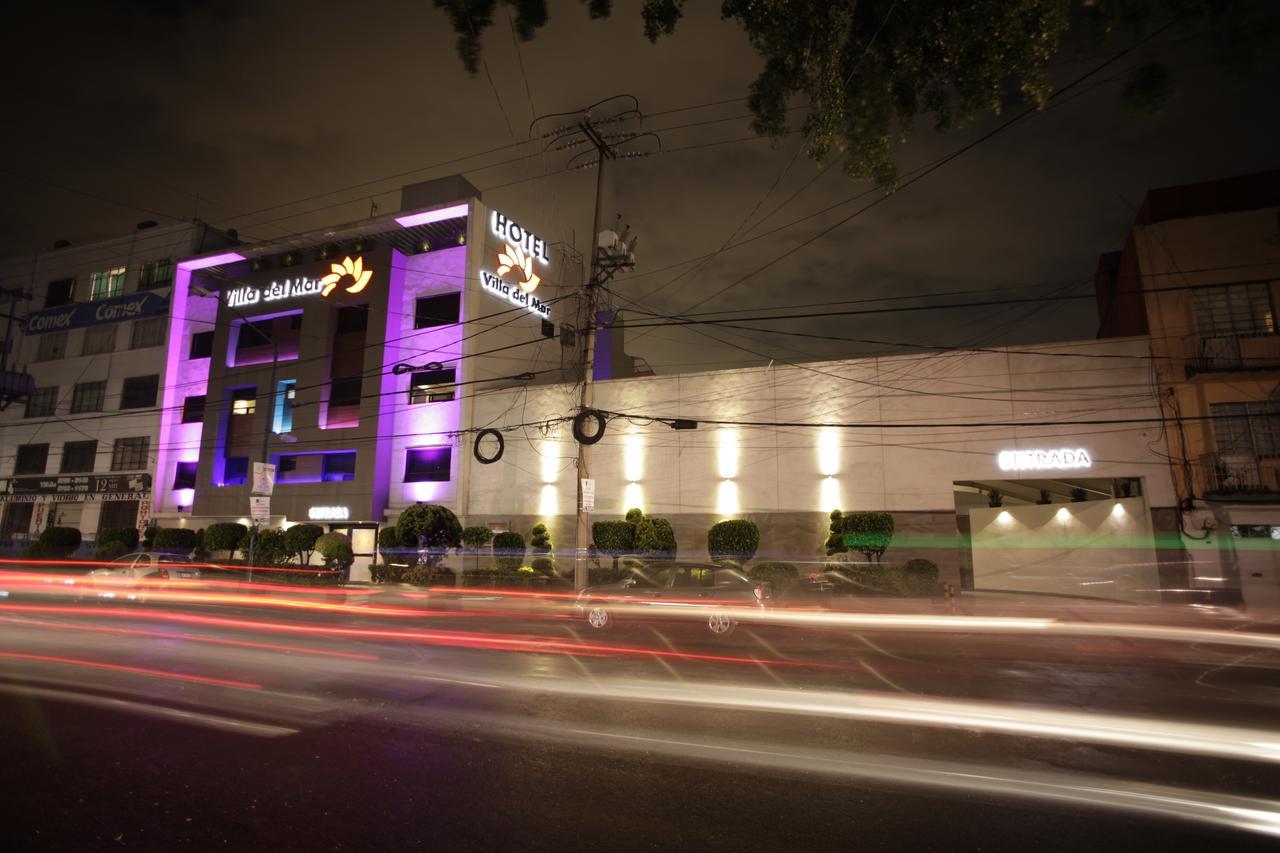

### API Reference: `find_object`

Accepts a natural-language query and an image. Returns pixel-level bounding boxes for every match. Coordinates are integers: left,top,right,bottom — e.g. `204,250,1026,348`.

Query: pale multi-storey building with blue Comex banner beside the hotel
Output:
0,223,232,547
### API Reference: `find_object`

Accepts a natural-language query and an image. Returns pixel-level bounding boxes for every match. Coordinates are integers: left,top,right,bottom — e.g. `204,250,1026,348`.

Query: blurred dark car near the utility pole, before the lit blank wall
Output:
576,562,772,637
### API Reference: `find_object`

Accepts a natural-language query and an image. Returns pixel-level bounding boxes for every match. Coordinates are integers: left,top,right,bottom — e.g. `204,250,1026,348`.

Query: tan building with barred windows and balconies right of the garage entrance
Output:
1097,170,1280,608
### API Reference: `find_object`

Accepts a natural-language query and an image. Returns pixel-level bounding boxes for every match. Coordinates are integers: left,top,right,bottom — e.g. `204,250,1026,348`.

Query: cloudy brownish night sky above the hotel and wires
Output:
0,0,1280,373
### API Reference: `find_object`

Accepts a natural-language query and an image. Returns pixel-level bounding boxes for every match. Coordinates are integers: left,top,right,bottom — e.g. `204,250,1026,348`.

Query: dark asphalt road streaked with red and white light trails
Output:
0,573,1280,850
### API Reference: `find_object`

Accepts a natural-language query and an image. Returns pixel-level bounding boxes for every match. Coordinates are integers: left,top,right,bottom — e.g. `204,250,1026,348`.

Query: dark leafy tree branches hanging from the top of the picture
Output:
434,0,1276,187
